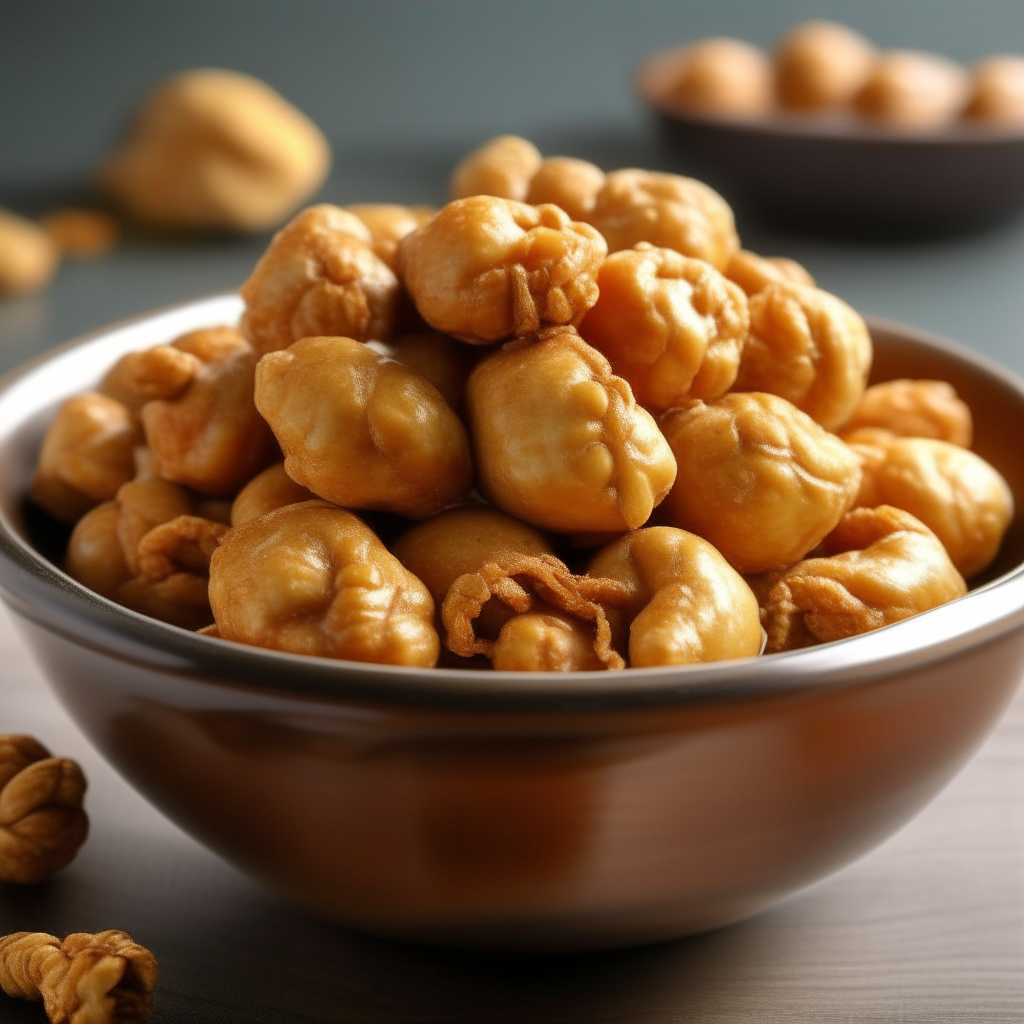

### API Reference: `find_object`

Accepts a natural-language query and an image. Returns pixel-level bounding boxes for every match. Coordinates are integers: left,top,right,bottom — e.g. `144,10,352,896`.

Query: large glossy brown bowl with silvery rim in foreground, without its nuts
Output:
0,296,1024,950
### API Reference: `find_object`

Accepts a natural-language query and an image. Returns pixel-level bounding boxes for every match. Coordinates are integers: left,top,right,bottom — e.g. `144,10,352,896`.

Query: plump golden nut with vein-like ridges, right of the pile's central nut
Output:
660,392,860,573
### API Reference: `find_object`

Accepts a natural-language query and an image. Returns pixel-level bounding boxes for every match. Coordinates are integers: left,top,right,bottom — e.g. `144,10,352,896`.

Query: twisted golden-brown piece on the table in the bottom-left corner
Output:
0,931,157,1024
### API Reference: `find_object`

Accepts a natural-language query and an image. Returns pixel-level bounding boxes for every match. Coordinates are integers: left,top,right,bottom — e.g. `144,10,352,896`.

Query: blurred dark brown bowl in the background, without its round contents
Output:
634,50,1024,238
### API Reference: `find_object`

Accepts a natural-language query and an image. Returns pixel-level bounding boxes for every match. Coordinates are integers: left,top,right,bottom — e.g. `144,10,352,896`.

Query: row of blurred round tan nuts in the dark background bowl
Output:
660,20,1024,131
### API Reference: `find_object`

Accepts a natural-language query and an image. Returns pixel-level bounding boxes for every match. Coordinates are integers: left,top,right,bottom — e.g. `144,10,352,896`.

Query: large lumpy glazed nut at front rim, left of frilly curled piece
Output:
210,501,440,668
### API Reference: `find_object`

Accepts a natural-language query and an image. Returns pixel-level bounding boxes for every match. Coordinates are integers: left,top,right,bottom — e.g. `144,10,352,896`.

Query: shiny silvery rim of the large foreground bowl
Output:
0,292,1024,714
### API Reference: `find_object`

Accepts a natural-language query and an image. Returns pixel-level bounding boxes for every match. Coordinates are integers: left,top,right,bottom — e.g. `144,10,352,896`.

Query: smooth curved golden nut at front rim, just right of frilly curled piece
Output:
587,526,762,669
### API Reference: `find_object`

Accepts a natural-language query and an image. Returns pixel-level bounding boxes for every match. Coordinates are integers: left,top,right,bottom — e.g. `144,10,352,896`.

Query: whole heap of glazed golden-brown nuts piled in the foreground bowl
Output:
31,136,1013,671
